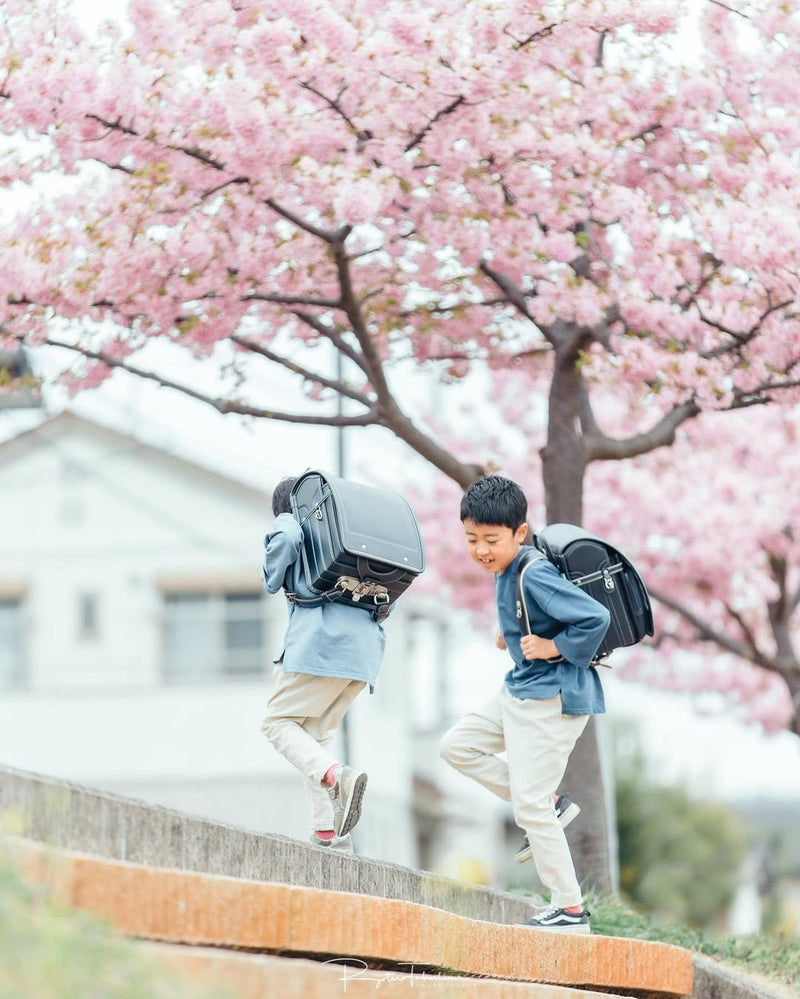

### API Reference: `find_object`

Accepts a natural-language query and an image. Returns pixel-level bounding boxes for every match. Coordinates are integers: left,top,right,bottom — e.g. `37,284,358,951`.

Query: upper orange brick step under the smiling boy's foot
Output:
9,837,693,999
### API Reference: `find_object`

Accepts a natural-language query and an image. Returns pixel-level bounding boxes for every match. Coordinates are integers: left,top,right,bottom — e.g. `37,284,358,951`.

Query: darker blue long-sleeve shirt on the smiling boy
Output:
495,552,611,715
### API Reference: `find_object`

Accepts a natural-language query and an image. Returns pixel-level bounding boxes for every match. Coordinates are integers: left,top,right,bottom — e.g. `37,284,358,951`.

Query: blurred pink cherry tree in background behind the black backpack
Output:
587,408,800,735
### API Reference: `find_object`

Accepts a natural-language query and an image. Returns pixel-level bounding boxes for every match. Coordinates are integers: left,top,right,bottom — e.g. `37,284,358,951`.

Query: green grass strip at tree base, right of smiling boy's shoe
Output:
586,894,800,995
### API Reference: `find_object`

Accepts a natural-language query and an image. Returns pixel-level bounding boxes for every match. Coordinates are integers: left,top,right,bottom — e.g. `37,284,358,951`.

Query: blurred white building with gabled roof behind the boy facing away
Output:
0,414,432,864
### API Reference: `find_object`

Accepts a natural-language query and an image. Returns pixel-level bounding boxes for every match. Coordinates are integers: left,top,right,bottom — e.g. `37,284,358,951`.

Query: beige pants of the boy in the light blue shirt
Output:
261,666,365,830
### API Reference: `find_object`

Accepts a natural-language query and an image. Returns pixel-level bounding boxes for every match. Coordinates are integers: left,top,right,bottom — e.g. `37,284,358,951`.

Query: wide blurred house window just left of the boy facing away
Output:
164,591,268,683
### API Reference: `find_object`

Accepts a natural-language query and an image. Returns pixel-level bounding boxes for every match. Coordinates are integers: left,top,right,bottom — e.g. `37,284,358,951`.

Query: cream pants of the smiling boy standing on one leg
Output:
441,684,589,908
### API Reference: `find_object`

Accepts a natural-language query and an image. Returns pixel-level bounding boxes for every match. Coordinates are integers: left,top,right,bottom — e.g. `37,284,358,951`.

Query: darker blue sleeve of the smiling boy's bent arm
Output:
525,561,611,666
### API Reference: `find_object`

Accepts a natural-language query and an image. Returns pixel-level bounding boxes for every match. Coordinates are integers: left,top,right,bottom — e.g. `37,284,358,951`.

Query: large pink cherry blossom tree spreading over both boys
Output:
0,0,800,892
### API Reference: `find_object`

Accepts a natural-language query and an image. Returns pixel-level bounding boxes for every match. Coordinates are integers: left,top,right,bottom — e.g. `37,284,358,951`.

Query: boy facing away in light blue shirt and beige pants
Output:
261,478,386,852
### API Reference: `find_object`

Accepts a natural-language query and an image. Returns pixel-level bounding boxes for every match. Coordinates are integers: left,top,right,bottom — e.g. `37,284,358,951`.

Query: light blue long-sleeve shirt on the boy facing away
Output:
264,513,386,686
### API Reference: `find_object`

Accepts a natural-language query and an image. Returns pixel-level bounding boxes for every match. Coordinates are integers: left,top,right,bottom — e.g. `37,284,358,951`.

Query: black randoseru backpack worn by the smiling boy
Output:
516,524,653,663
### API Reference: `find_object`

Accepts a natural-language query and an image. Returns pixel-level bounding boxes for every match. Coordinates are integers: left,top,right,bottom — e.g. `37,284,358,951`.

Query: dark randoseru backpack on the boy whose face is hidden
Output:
286,471,425,618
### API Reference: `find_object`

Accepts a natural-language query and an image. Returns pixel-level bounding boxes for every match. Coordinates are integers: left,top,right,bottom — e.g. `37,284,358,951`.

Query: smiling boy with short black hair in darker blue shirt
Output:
441,475,610,933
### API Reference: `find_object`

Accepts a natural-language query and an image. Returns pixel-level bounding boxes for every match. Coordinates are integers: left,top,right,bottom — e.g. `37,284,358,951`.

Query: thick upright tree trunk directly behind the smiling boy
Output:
542,337,618,892
